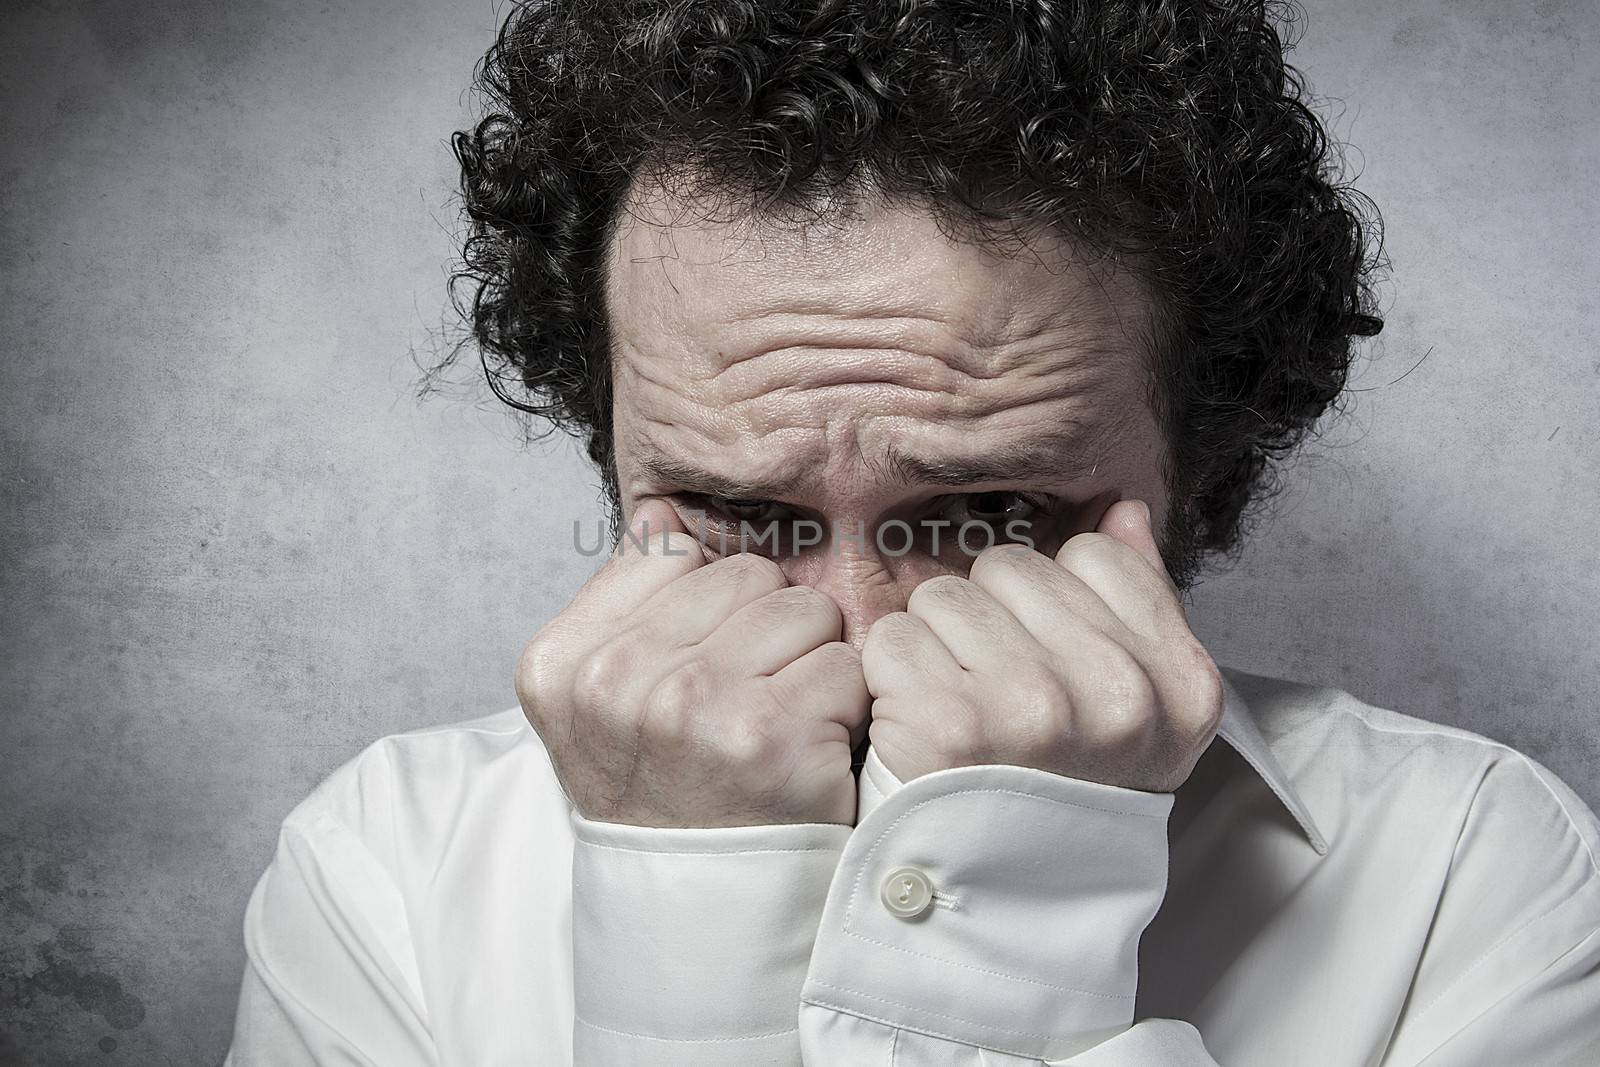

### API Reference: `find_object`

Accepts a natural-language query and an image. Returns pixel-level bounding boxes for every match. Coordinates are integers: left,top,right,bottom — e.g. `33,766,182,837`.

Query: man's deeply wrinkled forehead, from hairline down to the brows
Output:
606,175,1150,492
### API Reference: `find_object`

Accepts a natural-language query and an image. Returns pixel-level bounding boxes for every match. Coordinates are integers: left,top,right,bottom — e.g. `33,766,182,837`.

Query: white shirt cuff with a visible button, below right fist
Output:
802,750,1173,1059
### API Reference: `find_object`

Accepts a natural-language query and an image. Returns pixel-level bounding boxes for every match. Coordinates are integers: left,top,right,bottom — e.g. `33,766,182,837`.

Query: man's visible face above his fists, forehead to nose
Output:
606,182,1168,648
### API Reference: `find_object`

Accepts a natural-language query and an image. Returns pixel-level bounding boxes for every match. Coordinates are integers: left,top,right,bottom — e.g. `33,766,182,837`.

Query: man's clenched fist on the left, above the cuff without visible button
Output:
517,499,872,827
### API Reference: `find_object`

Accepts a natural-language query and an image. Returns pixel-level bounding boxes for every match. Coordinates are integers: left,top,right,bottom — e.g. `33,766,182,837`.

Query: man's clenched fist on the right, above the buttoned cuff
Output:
861,501,1222,792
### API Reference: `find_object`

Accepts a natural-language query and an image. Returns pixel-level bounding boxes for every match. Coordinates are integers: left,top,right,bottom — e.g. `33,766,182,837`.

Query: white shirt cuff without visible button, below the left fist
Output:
571,809,851,1065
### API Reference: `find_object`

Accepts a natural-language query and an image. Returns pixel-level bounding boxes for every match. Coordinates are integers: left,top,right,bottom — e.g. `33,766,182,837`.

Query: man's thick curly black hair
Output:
445,0,1384,589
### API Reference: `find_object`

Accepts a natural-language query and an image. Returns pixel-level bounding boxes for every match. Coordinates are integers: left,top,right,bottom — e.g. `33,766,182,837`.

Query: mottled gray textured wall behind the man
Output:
0,0,1600,1065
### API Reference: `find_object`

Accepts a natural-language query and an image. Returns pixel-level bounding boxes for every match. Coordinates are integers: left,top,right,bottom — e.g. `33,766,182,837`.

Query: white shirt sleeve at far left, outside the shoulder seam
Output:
224,790,438,1067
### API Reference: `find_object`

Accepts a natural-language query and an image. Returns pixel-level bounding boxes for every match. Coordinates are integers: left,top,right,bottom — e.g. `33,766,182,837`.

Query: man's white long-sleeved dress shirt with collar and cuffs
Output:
227,667,1600,1067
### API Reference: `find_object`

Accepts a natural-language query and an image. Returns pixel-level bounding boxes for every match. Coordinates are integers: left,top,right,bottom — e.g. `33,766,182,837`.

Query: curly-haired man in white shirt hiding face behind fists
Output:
230,0,1600,1067
